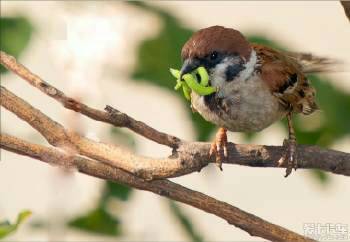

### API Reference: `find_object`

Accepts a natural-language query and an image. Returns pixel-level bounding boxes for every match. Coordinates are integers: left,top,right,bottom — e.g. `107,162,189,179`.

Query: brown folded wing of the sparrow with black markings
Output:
252,44,317,114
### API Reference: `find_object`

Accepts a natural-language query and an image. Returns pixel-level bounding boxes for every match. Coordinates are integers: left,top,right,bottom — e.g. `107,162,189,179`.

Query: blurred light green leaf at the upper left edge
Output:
0,17,33,73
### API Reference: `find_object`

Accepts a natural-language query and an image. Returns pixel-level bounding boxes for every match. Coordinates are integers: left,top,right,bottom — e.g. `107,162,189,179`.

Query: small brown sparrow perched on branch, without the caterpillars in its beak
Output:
180,26,333,177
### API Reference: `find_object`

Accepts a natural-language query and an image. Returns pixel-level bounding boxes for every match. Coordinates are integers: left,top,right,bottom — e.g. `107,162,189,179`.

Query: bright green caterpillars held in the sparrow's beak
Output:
170,66,217,100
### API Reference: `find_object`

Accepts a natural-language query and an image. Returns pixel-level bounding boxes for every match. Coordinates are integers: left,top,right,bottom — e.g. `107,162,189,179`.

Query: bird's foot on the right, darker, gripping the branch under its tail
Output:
278,139,298,177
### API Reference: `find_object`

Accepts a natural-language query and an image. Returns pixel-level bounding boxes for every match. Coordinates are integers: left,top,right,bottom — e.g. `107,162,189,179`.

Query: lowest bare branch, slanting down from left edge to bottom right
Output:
0,134,314,242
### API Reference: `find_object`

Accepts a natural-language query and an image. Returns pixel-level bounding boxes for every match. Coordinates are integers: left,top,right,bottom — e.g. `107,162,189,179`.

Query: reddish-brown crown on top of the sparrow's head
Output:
181,26,251,60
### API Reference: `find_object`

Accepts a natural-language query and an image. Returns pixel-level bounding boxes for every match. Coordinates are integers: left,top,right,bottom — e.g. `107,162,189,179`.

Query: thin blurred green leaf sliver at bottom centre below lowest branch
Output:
169,200,203,242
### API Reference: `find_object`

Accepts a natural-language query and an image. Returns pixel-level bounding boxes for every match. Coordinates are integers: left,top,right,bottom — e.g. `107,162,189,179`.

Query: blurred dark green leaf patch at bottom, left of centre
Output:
68,208,121,236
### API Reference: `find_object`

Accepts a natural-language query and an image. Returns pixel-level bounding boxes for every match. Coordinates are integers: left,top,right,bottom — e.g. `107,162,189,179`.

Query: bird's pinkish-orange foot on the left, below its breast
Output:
209,128,228,171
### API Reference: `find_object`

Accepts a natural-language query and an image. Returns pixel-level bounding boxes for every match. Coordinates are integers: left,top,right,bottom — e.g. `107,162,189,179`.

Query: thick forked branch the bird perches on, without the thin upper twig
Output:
0,87,350,180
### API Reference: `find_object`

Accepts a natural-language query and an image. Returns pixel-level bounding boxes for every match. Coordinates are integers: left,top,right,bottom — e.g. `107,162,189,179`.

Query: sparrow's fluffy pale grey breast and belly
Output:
191,76,286,132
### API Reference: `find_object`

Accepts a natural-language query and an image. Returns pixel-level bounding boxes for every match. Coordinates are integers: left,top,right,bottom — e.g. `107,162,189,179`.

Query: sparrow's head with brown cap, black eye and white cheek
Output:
181,26,252,87
